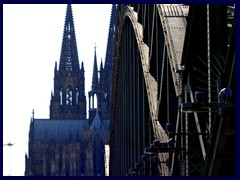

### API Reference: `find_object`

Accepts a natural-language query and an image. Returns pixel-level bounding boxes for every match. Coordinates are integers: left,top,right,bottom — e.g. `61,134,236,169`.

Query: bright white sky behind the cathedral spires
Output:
3,4,112,176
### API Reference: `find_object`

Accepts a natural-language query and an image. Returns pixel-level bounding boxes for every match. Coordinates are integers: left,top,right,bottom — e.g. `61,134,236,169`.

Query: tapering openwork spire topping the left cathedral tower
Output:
59,4,79,71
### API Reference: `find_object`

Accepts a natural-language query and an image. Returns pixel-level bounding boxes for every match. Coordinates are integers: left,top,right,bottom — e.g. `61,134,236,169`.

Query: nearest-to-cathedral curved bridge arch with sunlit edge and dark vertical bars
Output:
111,6,168,175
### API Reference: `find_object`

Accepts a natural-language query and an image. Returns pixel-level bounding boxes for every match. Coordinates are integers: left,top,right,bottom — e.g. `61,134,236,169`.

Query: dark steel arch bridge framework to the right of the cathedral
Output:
110,4,234,176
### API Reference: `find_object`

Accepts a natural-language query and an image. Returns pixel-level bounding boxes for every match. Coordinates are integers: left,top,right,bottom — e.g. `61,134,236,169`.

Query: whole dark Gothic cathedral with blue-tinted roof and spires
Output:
25,4,116,176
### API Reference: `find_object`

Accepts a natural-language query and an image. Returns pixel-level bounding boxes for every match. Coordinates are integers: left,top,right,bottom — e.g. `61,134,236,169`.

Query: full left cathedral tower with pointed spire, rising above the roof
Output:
50,4,86,119
